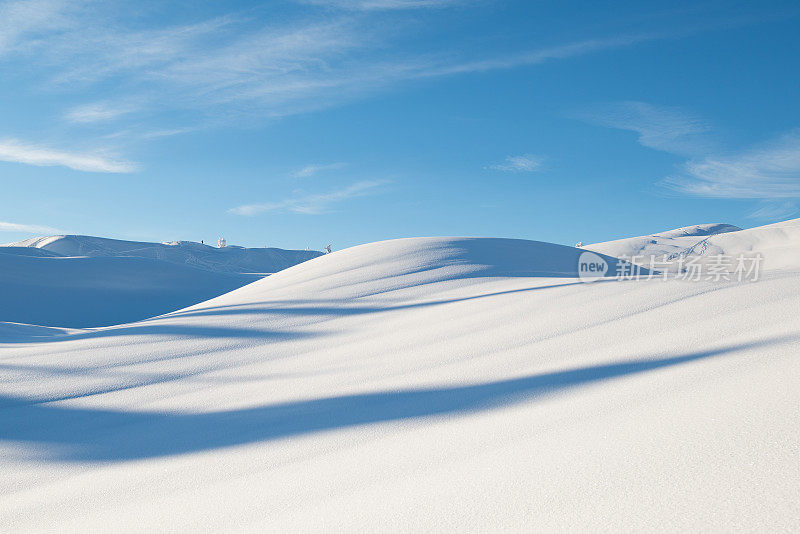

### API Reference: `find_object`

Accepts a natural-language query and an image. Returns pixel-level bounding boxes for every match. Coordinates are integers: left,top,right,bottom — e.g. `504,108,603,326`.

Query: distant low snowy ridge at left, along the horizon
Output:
5,235,322,273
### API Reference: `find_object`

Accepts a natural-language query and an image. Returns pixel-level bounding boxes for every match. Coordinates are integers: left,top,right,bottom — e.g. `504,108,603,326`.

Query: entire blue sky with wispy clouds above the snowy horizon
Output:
0,0,800,249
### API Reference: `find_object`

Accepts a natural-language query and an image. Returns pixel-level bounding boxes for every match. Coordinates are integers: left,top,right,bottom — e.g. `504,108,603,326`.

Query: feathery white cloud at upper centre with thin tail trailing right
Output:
152,31,656,116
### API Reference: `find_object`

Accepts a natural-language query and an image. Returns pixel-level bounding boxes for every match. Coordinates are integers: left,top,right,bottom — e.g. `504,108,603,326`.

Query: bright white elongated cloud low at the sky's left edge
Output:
0,139,137,173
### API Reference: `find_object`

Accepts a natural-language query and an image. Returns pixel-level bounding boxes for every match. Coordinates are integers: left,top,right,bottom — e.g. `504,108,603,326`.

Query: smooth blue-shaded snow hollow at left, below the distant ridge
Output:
0,249,261,328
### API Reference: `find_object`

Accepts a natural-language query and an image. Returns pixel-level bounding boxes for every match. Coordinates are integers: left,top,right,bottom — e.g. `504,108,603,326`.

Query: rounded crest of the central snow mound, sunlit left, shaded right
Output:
200,237,646,300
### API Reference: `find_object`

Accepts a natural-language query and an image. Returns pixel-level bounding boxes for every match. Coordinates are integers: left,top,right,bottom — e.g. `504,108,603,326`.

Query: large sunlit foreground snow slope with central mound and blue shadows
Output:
0,233,800,532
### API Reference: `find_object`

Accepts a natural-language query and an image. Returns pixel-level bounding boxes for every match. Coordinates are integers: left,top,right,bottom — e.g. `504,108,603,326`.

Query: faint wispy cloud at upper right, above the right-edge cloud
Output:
578,102,711,155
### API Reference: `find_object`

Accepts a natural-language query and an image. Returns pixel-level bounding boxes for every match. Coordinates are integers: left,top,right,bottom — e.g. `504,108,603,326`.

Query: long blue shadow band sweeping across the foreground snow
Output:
0,338,796,462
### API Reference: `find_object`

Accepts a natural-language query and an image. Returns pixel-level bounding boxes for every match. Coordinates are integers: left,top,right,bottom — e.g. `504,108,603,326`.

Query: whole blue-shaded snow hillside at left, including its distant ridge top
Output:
0,236,321,332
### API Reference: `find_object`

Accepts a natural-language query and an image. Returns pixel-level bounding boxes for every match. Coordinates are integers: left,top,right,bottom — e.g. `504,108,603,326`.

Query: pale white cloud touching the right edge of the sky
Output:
665,132,800,200
